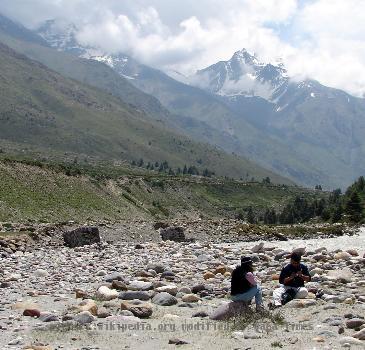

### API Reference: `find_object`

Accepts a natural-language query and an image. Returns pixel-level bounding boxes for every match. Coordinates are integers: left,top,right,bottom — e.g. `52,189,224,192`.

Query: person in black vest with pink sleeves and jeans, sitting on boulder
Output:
231,257,263,311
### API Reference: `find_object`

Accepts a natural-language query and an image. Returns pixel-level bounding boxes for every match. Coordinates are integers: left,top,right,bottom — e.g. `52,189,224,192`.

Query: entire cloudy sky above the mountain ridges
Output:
0,0,365,96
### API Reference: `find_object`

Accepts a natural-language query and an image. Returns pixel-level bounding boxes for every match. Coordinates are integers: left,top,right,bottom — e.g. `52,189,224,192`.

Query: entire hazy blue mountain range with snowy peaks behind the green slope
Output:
0,14,365,188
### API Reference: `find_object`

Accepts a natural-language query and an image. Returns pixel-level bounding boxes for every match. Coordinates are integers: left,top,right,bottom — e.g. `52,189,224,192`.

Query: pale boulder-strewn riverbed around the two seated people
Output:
0,228,365,350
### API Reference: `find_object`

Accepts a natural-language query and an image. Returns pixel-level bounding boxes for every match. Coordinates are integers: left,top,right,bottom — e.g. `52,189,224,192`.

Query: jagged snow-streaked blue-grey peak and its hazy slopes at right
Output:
190,50,365,190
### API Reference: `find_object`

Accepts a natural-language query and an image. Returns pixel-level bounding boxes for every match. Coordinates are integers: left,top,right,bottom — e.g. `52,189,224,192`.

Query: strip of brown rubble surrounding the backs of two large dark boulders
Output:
0,218,357,257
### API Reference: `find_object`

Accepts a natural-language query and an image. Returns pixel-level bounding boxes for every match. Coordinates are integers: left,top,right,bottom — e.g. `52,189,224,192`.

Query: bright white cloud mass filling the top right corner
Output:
286,0,365,96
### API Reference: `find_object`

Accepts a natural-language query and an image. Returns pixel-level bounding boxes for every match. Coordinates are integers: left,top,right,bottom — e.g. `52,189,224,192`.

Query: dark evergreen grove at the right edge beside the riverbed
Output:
242,176,365,225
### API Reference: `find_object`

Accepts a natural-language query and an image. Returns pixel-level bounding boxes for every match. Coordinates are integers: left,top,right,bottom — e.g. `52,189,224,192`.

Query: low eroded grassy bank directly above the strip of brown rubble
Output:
0,156,320,222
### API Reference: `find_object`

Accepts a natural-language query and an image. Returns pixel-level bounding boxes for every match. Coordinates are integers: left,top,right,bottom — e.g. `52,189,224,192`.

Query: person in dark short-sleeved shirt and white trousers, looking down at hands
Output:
270,252,311,307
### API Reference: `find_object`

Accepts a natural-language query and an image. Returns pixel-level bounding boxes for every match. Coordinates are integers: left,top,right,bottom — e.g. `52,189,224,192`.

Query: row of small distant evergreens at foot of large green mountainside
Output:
131,158,215,177
